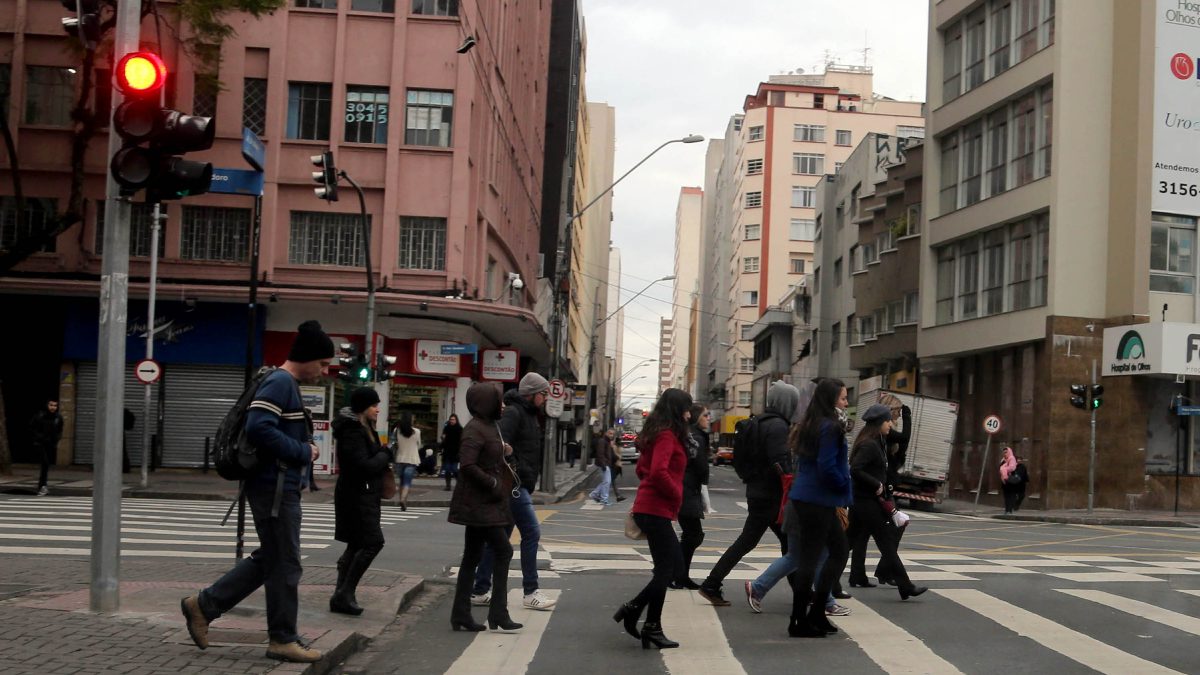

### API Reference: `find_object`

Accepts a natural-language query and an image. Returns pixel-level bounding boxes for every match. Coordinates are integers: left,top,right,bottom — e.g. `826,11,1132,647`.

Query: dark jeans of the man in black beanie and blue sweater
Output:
199,485,304,643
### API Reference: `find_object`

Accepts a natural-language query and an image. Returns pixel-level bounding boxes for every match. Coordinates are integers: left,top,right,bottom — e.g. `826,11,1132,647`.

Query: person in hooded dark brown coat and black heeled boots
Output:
449,383,521,631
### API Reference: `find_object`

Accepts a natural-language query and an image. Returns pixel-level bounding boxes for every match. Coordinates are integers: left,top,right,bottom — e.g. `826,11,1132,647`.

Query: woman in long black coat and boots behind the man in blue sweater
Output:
329,387,392,616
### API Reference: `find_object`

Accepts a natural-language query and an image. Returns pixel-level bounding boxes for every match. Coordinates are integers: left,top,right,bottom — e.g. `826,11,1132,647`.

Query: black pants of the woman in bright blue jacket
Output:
792,500,850,617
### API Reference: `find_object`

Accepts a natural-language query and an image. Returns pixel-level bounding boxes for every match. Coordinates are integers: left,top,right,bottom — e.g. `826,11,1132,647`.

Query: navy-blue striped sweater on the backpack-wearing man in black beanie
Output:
246,369,312,490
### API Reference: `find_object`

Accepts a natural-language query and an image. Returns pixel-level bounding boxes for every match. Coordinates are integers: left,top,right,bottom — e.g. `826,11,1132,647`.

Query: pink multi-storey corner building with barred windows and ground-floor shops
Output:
0,0,551,465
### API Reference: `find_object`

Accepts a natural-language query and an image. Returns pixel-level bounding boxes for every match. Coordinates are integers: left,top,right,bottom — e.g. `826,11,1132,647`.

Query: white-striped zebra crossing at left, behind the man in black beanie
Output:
0,496,445,560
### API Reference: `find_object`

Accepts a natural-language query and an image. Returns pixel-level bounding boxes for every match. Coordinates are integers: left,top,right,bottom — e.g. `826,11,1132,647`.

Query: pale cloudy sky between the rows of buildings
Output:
582,0,929,402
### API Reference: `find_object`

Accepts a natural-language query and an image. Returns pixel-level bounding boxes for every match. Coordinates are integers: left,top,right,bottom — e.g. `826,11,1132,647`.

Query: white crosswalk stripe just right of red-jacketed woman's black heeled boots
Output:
660,591,745,675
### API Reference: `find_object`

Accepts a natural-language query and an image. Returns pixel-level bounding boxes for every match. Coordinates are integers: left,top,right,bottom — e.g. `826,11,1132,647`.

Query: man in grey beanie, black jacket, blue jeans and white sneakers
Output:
470,372,556,610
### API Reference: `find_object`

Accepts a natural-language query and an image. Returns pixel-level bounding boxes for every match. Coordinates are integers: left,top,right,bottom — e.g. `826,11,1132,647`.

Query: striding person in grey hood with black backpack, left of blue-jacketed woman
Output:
700,380,800,607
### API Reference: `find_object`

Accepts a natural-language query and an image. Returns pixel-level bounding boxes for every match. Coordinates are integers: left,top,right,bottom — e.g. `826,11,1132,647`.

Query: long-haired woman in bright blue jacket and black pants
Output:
787,377,852,638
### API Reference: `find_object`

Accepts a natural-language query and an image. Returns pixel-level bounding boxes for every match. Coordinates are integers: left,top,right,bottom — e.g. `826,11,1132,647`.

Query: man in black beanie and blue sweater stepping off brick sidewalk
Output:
180,321,334,663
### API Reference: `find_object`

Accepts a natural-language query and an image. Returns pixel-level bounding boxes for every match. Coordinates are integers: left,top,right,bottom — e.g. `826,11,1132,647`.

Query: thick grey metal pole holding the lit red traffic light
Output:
89,0,142,611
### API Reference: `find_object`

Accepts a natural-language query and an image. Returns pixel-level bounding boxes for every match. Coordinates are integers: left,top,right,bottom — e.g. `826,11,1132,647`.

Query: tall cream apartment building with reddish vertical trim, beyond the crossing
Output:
714,64,925,429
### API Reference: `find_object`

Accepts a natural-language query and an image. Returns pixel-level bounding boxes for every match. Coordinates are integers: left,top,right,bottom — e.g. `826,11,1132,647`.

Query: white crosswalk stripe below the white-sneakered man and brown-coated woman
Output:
446,589,559,675
